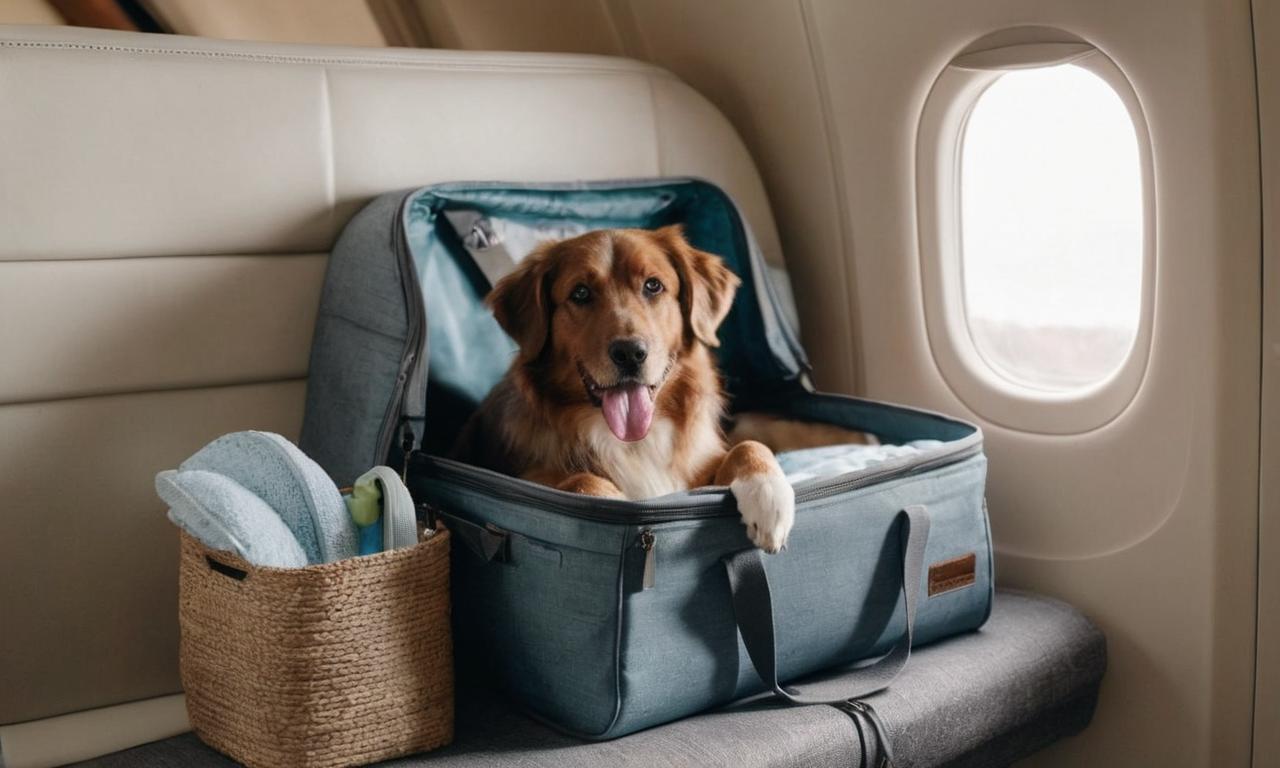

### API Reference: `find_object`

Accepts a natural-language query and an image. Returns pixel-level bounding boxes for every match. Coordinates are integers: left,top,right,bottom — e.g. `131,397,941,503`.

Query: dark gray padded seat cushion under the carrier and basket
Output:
74,591,1106,768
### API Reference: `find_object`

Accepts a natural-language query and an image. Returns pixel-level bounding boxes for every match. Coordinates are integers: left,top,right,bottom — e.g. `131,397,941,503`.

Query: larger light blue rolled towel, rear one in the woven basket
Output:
180,431,360,563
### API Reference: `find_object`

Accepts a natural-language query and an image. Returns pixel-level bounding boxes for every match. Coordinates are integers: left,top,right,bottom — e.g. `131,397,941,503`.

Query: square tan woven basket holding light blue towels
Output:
178,527,453,768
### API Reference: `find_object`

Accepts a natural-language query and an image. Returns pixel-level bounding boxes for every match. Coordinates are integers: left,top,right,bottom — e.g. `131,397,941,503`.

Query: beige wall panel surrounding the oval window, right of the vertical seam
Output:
798,0,1261,765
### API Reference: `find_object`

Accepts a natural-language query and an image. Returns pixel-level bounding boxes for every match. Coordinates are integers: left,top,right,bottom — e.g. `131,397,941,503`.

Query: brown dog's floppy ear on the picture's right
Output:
654,224,742,347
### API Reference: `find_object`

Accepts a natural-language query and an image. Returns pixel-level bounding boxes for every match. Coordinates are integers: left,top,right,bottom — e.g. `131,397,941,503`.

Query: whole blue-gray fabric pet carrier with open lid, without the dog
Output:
301,179,993,746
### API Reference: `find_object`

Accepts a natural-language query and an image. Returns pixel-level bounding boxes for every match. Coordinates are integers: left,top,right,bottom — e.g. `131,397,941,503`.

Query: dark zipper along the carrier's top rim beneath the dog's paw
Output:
417,440,982,525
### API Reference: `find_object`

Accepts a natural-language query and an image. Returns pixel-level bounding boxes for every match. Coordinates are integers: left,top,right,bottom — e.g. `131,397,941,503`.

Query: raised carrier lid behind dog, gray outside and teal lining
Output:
300,178,809,484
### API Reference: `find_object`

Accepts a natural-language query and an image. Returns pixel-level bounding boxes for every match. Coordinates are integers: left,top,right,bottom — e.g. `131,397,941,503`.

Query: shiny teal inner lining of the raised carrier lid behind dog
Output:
402,178,809,452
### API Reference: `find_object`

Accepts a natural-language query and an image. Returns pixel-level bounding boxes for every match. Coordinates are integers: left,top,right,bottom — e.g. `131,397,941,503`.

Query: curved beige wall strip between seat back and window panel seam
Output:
419,0,860,392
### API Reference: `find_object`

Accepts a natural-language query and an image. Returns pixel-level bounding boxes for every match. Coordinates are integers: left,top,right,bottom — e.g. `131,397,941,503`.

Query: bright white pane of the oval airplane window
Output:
960,64,1143,390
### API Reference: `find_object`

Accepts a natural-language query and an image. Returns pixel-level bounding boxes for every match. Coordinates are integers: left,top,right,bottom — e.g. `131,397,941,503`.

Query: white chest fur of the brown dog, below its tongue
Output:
582,416,722,499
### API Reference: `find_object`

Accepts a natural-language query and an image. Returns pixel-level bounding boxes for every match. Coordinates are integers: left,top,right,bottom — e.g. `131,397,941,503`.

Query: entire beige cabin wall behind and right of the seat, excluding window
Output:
420,0,1264,767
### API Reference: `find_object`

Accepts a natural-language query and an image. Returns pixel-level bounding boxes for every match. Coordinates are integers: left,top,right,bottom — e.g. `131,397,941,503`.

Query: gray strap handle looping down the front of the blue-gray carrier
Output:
723,506,929,704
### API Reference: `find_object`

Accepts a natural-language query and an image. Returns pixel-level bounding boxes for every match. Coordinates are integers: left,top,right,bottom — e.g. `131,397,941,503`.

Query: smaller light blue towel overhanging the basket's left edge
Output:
156,470,307,568
